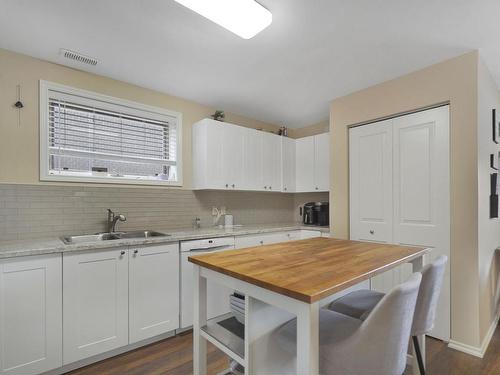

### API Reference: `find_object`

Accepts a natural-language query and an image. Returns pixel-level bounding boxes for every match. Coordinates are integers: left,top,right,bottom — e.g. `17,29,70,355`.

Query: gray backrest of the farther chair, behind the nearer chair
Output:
411,255,448,336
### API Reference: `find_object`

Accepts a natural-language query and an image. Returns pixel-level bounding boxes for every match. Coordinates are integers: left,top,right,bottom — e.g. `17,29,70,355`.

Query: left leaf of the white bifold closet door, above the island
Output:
349,120,393,243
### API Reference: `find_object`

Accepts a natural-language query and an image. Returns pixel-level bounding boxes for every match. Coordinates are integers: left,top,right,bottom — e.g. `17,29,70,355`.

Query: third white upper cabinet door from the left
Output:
242,129,264,190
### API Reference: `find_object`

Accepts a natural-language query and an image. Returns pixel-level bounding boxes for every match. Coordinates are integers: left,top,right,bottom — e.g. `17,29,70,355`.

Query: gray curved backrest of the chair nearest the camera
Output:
346,272,422,375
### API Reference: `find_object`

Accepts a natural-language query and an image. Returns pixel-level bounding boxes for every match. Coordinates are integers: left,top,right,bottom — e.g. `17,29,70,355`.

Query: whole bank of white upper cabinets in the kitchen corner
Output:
192,119,330,192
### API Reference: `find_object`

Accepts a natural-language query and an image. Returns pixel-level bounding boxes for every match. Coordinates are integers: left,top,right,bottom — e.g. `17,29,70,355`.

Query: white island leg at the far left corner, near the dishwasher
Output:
193,265,207,375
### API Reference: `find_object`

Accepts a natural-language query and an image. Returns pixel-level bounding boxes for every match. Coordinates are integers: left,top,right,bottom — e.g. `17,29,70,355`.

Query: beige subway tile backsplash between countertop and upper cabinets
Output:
0,184,328,240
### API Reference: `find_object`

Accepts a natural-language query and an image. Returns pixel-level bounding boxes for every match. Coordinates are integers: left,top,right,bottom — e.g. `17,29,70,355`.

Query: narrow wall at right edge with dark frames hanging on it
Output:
478,55,500,337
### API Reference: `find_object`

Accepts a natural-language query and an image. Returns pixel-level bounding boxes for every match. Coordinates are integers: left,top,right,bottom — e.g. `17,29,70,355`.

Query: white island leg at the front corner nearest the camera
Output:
297,302,319,375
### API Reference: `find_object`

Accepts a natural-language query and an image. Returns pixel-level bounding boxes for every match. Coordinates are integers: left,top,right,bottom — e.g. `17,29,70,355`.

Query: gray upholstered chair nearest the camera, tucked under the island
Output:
273,273,422,375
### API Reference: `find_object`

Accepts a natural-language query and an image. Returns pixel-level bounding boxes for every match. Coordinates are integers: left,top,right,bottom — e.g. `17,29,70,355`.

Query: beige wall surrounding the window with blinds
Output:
0,49,278,188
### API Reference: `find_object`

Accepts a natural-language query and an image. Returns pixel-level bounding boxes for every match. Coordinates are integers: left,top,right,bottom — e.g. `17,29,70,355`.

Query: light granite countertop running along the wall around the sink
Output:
0,223,330,259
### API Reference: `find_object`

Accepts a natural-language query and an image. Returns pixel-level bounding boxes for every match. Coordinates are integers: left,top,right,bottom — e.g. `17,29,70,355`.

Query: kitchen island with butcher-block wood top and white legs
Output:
189,238,429,375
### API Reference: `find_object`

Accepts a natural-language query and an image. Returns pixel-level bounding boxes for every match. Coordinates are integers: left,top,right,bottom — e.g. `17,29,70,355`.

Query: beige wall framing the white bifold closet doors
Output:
330,52,480,347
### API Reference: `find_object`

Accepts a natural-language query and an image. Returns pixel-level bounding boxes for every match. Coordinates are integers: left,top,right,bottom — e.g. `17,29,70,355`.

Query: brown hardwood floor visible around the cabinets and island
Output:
70,327,500,375
